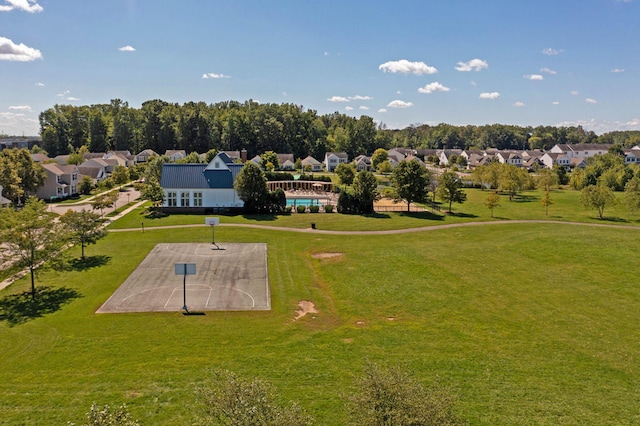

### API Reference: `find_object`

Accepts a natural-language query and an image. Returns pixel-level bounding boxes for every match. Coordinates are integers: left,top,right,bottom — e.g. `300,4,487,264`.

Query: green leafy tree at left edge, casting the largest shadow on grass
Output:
0,197,65,297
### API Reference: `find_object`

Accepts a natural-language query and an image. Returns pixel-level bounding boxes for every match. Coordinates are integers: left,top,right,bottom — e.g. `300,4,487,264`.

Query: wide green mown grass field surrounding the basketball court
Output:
0,191,640,425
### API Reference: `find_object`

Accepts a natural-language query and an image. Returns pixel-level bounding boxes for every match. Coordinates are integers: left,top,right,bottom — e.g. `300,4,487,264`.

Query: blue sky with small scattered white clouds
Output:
0,0,640,135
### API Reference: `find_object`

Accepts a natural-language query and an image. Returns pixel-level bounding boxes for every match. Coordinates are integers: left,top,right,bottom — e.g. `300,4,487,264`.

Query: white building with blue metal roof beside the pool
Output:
160,152,244,212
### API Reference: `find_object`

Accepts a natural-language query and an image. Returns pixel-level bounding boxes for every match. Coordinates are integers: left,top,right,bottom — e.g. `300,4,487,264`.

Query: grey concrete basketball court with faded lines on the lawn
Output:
96,243,271,313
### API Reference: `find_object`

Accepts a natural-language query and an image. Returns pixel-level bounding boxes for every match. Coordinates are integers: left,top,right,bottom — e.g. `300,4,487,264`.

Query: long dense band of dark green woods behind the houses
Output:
39,99,640,159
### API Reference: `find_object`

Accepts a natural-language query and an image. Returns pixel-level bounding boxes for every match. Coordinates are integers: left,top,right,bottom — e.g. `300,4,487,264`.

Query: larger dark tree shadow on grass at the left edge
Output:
0,287,82,327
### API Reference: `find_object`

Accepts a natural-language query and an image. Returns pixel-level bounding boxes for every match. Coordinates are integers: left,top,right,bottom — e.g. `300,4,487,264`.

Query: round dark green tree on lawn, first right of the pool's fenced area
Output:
391,160,431,211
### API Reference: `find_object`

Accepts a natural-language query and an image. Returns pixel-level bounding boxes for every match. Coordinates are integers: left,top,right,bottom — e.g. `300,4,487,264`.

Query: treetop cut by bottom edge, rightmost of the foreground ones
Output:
347,364,464,426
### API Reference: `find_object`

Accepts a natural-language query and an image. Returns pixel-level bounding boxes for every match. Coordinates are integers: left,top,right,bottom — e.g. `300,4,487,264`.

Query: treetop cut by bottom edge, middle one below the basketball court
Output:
198,371,314,426
